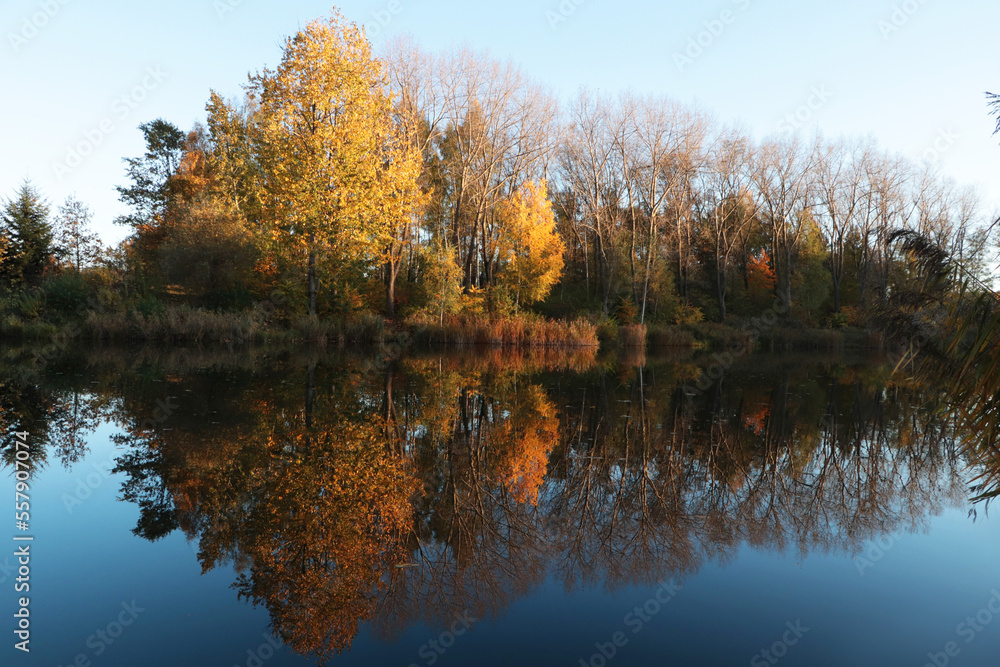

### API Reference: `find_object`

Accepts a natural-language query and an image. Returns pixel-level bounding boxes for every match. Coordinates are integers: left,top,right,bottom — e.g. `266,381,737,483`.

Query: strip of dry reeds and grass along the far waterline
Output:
0,306,885,351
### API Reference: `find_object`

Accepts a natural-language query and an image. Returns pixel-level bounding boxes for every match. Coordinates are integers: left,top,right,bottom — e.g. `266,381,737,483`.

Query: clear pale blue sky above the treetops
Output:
0,0,1000,242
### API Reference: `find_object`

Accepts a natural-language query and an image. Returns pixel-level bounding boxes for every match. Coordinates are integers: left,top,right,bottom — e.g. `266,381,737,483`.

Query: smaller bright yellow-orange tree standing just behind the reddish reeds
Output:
497,181,565,305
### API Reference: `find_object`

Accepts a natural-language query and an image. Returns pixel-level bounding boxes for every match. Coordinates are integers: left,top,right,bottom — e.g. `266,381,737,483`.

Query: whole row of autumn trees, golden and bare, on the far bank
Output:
0,7,994,336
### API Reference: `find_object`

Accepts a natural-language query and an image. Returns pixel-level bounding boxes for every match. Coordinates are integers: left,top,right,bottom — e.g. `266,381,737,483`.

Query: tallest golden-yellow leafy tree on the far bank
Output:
248,11,421,315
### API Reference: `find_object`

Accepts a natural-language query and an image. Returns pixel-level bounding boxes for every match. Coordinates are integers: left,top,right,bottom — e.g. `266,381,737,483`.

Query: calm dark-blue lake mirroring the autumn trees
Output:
0,348,1000,667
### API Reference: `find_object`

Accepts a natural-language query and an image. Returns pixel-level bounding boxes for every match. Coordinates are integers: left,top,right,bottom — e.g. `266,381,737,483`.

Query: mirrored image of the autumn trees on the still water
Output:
0,350,984,661
